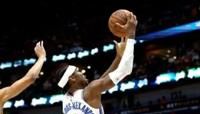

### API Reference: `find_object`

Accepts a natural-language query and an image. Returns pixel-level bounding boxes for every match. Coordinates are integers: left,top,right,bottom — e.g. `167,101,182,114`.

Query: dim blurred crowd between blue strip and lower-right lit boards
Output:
133,40,200,78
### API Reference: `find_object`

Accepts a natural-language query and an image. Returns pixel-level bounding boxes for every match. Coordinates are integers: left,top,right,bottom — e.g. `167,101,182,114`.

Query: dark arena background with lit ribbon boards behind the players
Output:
0,0,200,114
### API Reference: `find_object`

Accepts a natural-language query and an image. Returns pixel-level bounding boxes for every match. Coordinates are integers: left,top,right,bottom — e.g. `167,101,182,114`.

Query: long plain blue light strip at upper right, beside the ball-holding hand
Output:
137,20,200,41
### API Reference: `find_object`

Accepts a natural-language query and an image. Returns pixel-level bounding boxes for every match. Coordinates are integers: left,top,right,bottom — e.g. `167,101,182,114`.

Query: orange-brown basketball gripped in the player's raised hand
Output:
108,9,130,38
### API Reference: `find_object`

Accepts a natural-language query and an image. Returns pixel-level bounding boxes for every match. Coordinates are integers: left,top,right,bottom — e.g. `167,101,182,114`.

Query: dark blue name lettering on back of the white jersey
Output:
64,102,94,114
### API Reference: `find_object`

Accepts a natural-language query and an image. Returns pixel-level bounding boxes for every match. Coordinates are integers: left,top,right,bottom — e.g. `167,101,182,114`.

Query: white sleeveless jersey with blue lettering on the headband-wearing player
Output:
63,89,104,114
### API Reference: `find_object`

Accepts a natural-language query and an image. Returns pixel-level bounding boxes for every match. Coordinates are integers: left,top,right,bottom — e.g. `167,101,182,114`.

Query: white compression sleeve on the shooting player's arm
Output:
109,39,136,84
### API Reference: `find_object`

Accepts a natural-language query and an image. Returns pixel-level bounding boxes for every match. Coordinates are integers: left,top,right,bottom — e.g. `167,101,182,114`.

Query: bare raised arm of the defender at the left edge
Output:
0,41,46,114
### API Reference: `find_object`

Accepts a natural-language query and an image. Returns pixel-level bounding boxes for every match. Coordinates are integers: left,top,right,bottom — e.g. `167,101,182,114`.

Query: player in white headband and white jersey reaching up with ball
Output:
58,12,137,114
